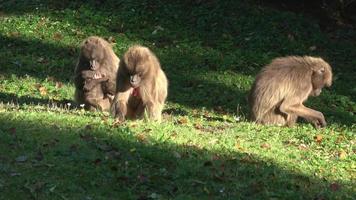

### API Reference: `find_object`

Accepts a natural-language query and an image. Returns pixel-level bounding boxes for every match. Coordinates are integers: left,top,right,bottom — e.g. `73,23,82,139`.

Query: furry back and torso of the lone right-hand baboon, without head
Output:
249,56,313,123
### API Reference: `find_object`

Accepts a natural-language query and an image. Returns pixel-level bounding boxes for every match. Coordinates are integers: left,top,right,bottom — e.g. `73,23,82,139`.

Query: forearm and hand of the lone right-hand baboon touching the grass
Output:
279,100,326,128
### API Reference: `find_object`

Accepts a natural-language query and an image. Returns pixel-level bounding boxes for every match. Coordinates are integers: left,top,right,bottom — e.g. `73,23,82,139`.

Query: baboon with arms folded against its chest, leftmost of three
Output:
74,36,120,111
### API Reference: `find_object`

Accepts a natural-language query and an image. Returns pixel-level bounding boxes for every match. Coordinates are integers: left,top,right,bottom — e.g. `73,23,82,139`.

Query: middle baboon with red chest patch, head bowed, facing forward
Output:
111,45,168,121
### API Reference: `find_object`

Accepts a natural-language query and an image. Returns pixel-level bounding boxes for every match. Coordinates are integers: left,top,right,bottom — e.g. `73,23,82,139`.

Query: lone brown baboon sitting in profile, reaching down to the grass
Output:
249,56,332,128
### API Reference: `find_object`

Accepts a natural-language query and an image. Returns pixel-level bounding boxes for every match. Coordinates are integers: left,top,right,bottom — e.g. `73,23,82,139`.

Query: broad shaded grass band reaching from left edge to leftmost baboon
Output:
0,35,78,82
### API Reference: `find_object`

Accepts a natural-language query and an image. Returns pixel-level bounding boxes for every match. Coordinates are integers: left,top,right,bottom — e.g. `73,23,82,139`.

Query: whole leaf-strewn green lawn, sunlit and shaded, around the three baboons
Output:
0,0,356,199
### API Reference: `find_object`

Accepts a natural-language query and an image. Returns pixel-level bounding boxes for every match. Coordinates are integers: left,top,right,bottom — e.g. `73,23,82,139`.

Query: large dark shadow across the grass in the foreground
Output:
0,115,354,199
